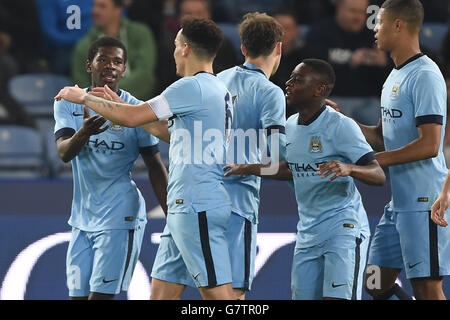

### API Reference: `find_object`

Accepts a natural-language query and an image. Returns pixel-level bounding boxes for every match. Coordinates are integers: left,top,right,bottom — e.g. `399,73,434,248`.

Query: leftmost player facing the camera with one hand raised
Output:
54,37,167,300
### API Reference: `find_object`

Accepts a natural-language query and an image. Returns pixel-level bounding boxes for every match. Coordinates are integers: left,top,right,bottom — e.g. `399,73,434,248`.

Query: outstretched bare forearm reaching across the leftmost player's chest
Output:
84,95,157,128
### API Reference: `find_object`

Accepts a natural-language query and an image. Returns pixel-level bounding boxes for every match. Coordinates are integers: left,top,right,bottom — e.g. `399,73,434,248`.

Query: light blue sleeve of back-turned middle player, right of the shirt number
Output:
260,87,286,133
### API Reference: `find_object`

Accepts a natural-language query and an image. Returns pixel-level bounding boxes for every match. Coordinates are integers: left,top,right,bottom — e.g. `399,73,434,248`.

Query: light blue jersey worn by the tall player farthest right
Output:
381,55,447,212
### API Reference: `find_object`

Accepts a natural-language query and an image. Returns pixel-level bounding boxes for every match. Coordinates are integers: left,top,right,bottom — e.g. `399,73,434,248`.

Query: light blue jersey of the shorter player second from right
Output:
286,106,375,248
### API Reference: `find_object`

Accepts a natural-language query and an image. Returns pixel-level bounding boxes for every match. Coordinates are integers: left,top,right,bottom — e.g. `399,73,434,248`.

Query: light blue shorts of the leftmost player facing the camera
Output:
66,223,145,297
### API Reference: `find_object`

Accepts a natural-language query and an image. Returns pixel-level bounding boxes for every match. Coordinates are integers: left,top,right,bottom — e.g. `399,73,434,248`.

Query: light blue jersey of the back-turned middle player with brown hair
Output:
218,63,286,223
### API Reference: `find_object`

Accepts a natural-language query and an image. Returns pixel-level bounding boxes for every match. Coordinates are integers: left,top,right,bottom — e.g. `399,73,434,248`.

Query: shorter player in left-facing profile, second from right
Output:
224,59,385,300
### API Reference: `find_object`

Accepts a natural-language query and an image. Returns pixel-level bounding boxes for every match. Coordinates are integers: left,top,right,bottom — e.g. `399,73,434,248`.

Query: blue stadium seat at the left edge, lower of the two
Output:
0,125,48,178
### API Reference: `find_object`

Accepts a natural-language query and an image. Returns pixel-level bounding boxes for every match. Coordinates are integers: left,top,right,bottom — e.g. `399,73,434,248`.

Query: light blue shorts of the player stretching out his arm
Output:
151,206,232,287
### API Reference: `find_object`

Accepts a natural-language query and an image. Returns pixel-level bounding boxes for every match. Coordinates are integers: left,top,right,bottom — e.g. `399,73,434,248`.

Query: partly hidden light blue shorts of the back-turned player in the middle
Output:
227,212,258,290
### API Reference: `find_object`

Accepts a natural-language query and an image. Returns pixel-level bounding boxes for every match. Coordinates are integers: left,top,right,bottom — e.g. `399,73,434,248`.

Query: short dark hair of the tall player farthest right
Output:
381,0,425,33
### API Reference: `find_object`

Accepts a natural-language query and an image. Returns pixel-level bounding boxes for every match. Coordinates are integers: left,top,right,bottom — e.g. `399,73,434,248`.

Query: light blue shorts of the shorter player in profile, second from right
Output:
291,235,369,300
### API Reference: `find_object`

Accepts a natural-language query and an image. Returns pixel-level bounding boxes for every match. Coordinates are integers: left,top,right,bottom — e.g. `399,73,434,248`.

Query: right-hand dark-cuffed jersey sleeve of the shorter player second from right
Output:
335,117,375,165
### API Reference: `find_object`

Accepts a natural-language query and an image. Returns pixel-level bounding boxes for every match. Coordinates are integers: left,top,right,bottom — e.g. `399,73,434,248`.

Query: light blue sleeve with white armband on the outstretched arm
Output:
147,77,202,120
